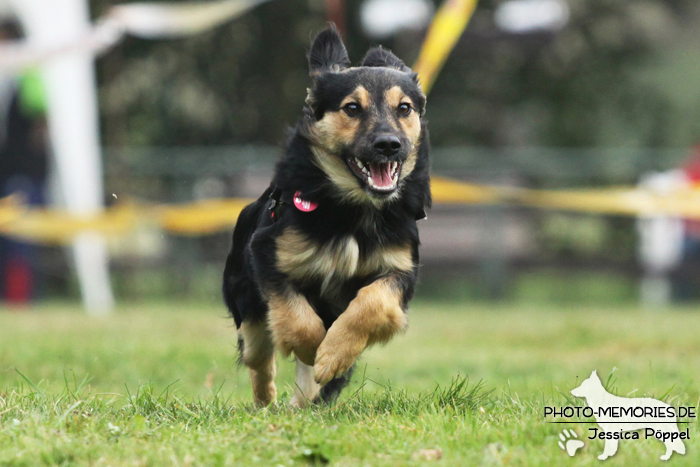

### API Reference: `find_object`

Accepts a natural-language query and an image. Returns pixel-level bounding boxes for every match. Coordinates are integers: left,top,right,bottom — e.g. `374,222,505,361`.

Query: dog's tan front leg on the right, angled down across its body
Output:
314,275,407,385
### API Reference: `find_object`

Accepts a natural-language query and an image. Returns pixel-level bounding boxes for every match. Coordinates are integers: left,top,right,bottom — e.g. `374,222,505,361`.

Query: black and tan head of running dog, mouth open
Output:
306,26,427,204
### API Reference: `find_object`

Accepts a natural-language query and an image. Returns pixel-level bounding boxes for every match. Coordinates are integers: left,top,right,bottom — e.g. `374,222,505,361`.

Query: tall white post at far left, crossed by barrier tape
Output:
11,0,114,315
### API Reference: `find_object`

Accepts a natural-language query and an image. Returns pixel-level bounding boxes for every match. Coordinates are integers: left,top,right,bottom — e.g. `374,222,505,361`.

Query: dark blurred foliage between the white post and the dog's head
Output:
92,0,325,146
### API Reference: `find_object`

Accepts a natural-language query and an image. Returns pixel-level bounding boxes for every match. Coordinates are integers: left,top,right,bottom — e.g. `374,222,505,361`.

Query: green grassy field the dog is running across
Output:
0,303,700,466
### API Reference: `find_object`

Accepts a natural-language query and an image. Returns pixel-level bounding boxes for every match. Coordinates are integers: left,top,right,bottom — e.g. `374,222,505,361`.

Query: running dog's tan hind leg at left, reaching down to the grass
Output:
238,321,277,406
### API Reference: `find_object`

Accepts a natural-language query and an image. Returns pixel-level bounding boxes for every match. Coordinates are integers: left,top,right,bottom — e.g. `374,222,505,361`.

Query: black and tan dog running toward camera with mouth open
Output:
223,26,431,406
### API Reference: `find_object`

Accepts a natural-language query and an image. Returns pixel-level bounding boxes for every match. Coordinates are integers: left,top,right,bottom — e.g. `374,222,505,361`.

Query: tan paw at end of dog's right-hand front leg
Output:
314,328,367,386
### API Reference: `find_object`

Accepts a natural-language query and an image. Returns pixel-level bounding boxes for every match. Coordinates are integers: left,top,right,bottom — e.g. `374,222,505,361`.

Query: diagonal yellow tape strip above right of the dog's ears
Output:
413,0,478,94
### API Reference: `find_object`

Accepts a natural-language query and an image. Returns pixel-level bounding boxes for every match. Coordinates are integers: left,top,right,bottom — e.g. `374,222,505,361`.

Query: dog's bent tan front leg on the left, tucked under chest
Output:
268,289,326,366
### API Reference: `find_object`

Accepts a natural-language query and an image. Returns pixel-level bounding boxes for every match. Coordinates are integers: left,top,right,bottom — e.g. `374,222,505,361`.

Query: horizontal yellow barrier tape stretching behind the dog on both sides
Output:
0,177,700,245
